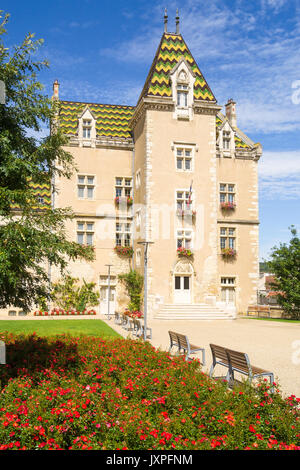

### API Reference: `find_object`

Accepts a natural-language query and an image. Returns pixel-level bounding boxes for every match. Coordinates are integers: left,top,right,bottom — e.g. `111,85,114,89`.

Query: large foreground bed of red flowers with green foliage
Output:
0,333,300,451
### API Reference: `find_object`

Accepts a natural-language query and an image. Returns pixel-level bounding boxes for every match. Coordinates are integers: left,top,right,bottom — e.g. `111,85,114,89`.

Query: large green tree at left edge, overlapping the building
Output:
0,12,94,310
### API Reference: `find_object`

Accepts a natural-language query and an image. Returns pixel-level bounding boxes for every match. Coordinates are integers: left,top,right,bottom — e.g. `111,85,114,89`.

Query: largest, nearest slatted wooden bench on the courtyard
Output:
209,344,274,391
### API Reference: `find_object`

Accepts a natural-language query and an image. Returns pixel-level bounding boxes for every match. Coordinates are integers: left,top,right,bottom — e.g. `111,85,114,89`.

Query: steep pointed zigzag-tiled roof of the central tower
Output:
139,33,216,102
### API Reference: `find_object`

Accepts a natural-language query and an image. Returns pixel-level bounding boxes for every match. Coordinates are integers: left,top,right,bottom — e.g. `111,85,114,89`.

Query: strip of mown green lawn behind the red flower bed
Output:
0,319,120,338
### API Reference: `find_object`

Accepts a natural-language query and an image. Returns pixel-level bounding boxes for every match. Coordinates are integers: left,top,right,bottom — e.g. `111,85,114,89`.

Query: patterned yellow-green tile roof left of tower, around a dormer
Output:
59,101,135,139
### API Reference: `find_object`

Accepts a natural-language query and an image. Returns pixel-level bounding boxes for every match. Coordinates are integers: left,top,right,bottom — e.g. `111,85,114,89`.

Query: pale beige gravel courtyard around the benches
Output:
101,316,300,397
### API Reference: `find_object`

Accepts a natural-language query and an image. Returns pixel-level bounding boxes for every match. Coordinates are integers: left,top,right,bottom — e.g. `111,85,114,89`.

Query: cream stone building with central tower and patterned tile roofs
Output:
48,16,262,324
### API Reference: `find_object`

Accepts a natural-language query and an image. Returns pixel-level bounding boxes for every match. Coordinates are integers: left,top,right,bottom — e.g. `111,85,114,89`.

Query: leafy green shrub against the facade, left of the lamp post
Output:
52,275,99,312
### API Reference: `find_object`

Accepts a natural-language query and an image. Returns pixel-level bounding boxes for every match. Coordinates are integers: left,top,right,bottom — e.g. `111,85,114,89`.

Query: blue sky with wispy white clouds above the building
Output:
1,0,300,259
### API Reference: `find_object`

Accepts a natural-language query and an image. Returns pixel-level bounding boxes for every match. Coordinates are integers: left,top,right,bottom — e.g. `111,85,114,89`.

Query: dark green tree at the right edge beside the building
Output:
268,226,300,319
